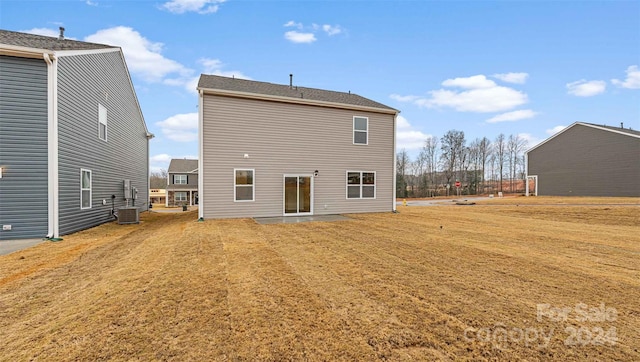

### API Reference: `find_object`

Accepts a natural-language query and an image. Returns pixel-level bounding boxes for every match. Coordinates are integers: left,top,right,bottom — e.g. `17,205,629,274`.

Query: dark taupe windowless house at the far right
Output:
526,122,640,197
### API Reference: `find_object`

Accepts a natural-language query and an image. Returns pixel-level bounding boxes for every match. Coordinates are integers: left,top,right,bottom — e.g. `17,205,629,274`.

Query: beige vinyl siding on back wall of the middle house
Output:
200,95,394,218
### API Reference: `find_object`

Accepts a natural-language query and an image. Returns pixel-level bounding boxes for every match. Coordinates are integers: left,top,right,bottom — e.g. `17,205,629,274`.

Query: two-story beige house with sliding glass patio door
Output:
198,75,398,218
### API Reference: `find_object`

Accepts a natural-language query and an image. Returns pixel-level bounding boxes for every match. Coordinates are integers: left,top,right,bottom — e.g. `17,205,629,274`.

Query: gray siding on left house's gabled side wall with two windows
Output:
58,52,149,234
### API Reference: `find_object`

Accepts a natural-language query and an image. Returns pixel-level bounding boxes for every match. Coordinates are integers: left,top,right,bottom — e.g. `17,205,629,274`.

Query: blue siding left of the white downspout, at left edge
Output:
0,56,48,240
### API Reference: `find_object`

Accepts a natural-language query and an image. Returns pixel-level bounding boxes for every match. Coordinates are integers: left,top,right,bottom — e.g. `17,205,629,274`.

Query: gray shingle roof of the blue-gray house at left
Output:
0,30,118,51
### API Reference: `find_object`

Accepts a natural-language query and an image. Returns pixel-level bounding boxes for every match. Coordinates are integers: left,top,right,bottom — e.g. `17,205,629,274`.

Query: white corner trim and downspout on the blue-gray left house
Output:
42,53,60,241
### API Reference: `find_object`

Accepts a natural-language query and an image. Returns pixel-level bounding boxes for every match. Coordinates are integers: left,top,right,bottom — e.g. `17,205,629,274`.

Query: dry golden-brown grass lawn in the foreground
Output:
0,198,640,361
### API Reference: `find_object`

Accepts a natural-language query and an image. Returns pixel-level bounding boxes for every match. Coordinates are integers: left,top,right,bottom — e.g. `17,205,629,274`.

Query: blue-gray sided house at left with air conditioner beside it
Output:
0,29,152,240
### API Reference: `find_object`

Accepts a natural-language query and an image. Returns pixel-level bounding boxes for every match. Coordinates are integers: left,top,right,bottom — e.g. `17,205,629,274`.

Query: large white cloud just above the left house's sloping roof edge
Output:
85,26,193,82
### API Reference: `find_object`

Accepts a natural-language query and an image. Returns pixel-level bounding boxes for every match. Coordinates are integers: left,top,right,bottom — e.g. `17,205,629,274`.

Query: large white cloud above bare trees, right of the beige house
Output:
391,74,528,113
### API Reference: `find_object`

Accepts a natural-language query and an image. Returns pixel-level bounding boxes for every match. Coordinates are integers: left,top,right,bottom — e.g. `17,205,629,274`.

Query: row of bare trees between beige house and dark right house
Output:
396,130,528,197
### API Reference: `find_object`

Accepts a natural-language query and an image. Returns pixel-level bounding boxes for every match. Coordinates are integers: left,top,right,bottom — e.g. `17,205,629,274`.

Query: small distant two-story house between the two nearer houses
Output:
166,159,198,206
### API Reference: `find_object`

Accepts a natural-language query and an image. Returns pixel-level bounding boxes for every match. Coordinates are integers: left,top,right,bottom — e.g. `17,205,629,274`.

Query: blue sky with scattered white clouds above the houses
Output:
0,0,640,170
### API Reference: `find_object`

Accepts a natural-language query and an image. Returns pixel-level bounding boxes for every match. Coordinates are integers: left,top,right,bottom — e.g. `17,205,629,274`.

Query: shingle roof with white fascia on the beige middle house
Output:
198,74,398,113
